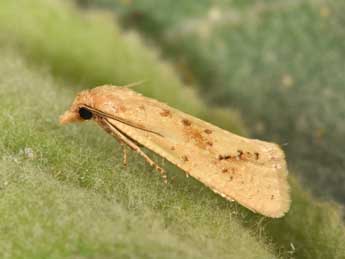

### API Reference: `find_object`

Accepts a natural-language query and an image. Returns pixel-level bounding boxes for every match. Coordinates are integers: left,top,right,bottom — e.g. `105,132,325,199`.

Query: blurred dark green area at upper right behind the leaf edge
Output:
83,0,345,204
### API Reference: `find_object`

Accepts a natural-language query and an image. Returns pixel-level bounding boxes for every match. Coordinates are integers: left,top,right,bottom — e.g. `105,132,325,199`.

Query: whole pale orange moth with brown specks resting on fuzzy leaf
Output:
60,85,290,218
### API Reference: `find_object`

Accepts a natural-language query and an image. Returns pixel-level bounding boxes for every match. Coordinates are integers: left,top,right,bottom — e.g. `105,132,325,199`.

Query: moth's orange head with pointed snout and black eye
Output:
60,91,93,124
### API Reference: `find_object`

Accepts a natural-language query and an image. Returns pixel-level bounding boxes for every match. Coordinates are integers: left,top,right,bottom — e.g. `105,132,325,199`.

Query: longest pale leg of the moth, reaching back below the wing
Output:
104,120,167,183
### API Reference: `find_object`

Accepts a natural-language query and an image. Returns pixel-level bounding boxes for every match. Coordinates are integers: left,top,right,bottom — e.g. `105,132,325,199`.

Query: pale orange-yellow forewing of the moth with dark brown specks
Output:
90,86,290,217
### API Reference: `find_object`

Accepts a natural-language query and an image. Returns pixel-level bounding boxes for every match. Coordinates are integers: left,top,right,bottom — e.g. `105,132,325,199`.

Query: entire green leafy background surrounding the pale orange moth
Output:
0,0,345,258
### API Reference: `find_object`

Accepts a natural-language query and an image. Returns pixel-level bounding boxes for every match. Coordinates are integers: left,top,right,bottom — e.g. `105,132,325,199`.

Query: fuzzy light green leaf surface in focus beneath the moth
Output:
0,47,345,258
